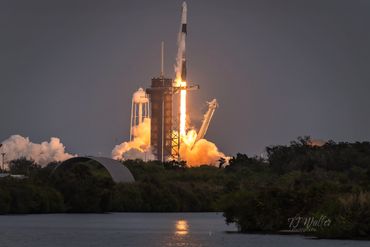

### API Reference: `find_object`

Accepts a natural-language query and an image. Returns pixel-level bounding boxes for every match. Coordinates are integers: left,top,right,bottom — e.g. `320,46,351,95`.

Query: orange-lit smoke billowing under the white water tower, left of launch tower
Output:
112,118,154,160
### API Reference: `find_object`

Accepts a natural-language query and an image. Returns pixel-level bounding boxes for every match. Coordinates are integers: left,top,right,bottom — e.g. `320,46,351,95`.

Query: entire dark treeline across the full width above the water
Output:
0,137,370,238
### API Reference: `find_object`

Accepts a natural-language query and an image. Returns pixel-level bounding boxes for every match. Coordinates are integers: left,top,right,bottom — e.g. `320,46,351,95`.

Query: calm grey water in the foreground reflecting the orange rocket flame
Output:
0,213,370,247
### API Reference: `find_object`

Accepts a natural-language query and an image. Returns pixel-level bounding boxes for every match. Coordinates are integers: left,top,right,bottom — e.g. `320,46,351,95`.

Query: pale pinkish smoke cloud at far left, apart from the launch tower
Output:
2,135,73,166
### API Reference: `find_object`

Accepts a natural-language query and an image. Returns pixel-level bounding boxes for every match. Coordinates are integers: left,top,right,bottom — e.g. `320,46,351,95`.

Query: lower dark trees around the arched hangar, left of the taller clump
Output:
0,159,232,214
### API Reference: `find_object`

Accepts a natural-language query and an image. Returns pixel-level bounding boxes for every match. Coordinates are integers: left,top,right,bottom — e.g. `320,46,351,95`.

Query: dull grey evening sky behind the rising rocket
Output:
0,0,370,155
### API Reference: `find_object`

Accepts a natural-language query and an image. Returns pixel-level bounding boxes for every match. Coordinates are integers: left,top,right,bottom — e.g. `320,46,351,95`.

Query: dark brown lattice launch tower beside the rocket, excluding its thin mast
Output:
146,76,173,161
